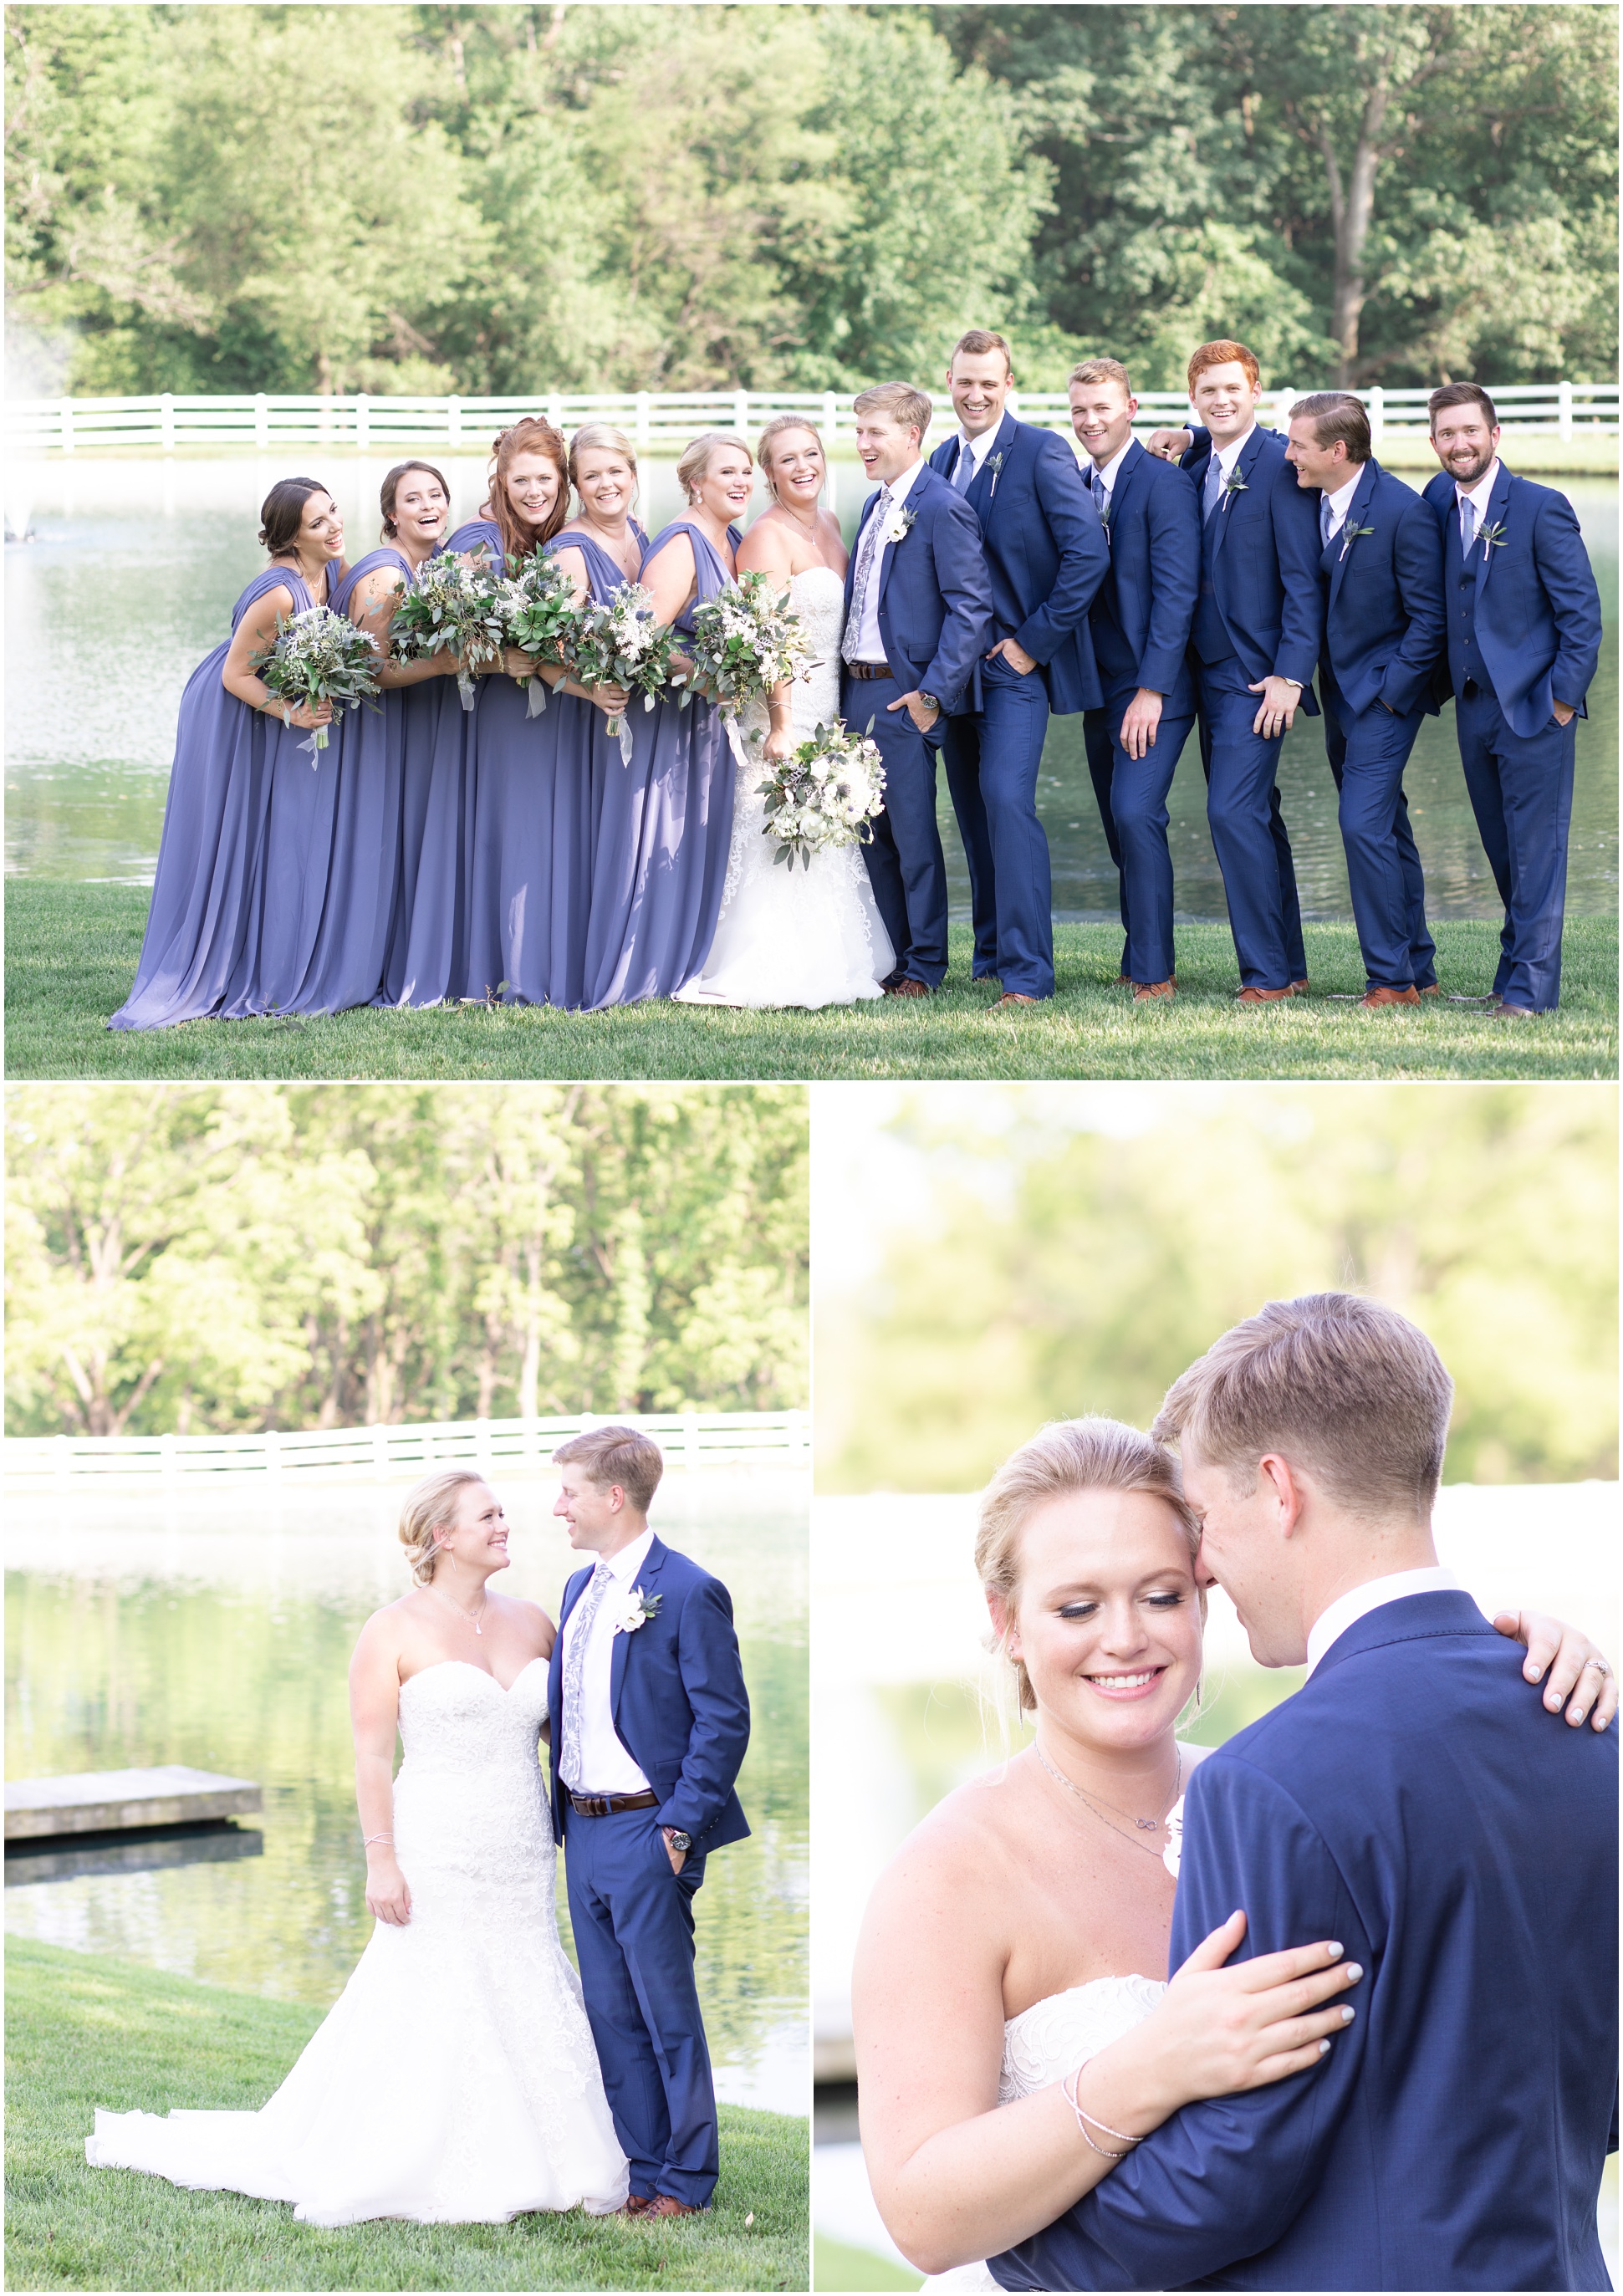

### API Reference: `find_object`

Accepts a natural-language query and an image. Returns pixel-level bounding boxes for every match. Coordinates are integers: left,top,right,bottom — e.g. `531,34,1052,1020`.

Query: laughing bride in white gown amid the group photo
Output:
675,416,896,1010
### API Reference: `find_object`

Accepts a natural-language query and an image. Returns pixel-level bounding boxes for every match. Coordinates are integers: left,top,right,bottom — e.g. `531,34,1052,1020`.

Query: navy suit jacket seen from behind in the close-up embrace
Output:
992,1591,1619,2289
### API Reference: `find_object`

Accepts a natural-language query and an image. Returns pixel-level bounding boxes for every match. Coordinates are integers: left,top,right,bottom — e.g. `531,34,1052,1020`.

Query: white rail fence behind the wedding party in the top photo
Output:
4,384,1619,455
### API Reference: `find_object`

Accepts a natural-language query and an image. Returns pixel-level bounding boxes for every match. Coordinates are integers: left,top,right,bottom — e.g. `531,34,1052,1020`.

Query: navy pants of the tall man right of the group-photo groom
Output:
942,655,1054,997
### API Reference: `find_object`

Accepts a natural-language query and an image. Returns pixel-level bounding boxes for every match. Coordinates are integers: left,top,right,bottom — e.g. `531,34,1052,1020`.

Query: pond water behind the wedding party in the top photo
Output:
7,447,1619,918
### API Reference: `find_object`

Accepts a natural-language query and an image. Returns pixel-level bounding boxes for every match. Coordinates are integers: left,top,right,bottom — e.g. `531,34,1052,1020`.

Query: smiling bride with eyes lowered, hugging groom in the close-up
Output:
852,1419,1614,2289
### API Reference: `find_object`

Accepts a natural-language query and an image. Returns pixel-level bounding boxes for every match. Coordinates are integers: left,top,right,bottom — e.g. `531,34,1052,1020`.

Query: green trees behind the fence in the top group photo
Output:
7,4,1616,395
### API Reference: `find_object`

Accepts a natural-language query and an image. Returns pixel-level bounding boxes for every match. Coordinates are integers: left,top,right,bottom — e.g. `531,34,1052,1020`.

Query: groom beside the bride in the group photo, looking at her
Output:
840,384,992,997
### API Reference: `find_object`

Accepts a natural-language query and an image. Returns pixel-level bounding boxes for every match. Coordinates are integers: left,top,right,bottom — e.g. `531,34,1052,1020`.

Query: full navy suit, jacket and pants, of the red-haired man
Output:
1185,430,1324,990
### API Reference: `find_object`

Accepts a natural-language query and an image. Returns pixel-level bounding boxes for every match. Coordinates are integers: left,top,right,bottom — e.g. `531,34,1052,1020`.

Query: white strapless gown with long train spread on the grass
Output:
85,1658,626,2225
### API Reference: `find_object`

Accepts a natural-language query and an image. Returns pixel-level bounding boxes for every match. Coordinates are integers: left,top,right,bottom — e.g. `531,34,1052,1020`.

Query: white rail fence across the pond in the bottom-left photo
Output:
3,1412,810,1487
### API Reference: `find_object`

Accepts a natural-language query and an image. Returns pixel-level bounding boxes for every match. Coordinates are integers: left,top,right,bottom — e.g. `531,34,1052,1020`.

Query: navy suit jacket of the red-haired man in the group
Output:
1182,427,1324,717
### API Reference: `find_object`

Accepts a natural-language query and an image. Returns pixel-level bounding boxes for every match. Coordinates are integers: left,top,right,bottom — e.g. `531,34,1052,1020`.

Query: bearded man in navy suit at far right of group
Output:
1426,384,1600,1019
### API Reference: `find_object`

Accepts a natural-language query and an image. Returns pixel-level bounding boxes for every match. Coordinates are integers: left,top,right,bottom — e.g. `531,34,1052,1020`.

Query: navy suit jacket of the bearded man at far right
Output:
1426,464,1600,735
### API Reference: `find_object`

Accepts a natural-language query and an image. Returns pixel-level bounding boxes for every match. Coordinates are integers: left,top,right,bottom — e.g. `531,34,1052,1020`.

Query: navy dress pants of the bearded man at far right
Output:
1453,686,1577,1013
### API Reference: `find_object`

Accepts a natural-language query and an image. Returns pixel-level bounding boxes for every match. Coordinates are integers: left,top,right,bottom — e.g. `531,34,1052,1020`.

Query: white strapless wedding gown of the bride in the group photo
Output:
677,567,896,1010
